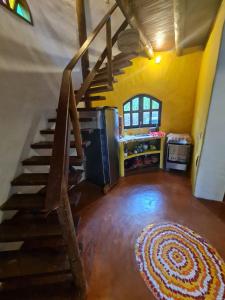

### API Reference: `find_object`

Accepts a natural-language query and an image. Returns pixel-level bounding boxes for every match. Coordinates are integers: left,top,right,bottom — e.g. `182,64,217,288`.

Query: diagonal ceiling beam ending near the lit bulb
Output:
116,0,154,58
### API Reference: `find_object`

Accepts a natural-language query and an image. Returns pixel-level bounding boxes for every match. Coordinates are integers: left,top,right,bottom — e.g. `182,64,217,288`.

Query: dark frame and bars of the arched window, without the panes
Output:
123,94,162,129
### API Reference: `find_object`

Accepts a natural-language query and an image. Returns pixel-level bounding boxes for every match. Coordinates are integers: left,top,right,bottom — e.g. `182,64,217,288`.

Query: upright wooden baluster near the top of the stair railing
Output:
106,17,113,87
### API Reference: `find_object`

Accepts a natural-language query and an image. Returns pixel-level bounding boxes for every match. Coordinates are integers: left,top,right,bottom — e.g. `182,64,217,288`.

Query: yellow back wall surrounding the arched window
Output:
94,51,202,132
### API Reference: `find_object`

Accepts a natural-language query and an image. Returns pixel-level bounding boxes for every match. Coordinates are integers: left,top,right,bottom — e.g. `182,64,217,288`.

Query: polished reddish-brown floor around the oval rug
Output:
79,171,225,300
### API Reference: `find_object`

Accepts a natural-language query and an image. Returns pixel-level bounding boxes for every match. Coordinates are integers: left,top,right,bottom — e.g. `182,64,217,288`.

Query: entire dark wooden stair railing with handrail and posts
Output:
45,4,127,300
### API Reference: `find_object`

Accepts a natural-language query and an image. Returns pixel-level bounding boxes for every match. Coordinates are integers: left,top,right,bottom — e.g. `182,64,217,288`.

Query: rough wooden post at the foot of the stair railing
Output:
57,180,87,300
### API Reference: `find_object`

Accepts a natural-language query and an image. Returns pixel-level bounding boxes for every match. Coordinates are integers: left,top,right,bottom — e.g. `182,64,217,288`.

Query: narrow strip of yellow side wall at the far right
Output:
192,1,225,186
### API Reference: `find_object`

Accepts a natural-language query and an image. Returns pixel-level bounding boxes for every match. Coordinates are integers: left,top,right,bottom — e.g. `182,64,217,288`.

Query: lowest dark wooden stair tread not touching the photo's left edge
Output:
12,170,83,186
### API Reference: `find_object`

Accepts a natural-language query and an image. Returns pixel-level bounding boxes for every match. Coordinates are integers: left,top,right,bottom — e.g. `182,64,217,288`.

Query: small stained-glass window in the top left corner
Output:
0,0,33,25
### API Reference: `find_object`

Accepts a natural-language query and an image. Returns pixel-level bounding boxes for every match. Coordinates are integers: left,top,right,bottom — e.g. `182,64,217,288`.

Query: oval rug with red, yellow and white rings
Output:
135,223,225,300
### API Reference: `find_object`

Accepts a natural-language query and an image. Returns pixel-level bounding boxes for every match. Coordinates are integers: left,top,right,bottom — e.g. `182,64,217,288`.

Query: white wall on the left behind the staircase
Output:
0,0,123,221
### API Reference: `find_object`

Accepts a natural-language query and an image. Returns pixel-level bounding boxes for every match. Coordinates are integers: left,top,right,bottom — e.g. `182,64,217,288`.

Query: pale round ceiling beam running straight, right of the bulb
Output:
173,0,187,56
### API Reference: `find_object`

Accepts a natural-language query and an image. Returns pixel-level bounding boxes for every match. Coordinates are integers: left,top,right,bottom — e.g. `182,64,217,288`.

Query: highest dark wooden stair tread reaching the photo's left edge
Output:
1,194,45,211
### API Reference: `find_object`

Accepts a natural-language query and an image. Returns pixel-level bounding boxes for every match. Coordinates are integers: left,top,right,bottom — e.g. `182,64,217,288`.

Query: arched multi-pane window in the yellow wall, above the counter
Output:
123,95,162,128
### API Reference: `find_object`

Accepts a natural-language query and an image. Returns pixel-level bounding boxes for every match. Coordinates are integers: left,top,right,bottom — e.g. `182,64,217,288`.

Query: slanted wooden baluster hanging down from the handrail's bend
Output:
70,79,84,159
